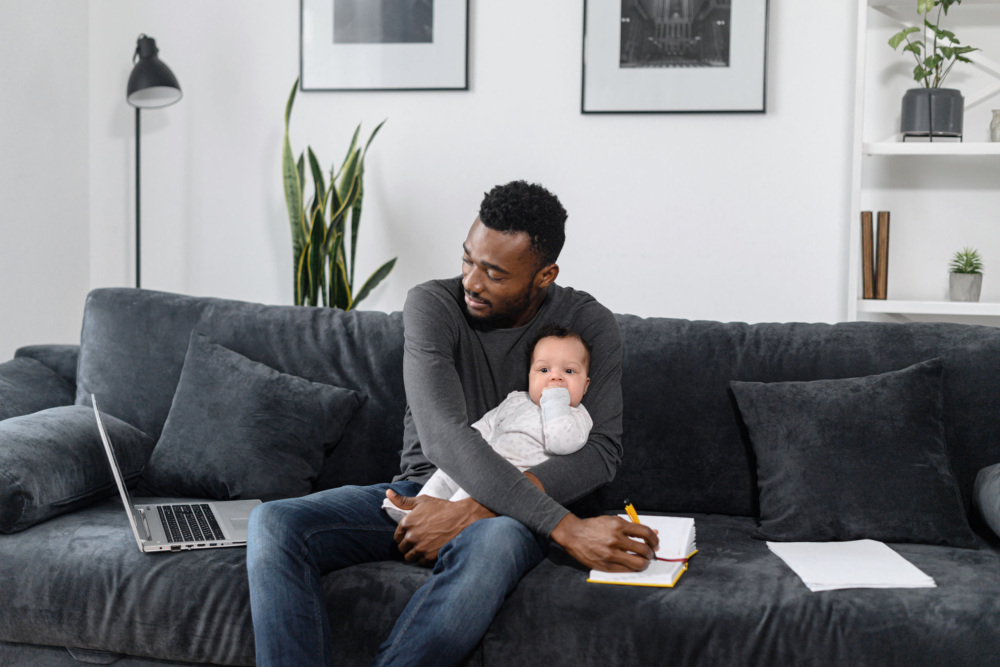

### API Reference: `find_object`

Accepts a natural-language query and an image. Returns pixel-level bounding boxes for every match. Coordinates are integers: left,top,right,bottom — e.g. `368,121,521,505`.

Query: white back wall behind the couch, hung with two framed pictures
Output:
0,0,855,362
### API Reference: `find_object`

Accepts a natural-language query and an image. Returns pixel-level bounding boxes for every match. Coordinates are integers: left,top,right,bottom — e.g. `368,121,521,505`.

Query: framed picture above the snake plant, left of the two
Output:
299,0,469,91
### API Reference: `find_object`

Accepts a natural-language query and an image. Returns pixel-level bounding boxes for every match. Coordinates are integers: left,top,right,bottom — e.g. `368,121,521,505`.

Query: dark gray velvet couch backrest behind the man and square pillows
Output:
77,288,1000,516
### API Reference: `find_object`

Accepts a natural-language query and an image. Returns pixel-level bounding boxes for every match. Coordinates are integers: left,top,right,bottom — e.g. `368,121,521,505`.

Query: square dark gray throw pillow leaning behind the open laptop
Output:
143,333,362,500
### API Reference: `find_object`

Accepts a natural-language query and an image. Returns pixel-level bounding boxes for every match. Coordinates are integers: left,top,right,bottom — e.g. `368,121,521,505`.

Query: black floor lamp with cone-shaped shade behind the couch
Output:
126,35,181,287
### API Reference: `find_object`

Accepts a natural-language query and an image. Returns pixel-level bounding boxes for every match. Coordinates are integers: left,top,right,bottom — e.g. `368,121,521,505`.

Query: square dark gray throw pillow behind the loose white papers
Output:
730,359,976,547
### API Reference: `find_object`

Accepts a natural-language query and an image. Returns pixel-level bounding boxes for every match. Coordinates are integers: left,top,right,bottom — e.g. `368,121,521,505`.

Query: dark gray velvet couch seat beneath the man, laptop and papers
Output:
0,508,1000,667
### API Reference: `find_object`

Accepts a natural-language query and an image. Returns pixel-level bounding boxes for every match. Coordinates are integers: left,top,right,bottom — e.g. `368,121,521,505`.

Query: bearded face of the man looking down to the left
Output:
462,218,554,328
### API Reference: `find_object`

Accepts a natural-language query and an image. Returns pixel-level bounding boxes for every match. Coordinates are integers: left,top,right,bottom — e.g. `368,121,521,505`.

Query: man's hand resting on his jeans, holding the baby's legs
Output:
385,489,496,566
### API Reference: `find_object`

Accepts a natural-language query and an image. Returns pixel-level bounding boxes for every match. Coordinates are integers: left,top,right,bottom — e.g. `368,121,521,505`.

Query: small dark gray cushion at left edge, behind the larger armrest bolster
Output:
0,357,73,420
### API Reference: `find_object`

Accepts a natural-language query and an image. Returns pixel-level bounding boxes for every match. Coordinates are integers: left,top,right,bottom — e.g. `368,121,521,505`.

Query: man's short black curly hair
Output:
479,181,566,268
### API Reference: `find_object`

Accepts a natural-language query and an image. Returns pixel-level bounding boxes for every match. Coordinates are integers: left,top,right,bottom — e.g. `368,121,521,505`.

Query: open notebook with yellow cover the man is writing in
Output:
587,514,698,588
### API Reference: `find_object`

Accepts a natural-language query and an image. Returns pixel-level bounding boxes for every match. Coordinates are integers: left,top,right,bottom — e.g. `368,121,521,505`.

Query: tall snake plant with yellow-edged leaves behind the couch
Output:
281,79,396,310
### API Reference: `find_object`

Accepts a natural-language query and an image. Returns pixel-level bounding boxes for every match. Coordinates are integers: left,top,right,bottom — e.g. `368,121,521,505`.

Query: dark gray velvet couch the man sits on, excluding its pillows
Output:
0,289,1000,666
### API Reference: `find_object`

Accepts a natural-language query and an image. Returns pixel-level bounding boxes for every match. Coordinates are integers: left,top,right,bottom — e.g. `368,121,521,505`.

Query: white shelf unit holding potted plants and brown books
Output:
846,0,1000,325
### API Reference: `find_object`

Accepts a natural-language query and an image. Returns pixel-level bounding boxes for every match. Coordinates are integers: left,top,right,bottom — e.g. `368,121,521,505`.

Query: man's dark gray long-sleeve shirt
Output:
396,278,622,536
